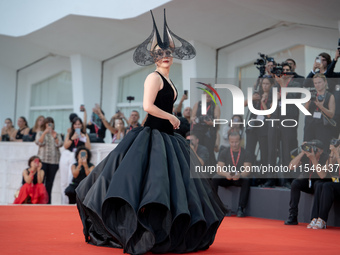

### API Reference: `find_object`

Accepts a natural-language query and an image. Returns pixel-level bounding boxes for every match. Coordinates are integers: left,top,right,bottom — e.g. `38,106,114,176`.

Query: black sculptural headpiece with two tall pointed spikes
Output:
133,9,196,66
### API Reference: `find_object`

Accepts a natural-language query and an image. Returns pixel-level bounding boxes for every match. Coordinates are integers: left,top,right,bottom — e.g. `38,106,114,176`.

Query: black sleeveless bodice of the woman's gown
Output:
144,72,178,135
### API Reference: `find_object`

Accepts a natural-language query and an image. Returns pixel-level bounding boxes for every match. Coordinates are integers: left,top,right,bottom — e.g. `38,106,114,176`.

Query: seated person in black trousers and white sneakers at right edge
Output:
307,139,340,229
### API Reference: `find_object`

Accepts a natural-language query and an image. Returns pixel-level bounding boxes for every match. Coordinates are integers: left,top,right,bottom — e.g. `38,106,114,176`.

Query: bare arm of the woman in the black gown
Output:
143,73,180,129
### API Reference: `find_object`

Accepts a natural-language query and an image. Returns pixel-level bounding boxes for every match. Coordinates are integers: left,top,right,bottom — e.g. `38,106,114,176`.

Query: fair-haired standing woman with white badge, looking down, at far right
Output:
304,74,336,151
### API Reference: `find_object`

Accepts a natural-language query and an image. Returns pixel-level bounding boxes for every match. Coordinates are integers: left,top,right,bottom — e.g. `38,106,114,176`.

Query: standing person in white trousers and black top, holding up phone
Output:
59,117,91,204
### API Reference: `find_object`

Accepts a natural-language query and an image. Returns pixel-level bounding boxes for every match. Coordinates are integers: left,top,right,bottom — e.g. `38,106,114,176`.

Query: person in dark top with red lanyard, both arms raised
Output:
83,105,106,143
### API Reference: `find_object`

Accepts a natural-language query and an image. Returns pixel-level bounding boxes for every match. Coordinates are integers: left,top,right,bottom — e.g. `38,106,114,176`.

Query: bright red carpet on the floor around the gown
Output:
0,205,340,255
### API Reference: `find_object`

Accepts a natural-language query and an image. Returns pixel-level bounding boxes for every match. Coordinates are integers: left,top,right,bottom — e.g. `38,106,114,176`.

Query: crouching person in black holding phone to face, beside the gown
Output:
65,147,94,204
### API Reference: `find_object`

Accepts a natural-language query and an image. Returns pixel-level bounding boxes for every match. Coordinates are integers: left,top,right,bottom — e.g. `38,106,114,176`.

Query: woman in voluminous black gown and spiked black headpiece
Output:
76,8,225,254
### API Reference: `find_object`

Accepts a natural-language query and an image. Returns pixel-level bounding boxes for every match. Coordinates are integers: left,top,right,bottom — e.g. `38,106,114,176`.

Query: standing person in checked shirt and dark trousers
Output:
35,117,63,204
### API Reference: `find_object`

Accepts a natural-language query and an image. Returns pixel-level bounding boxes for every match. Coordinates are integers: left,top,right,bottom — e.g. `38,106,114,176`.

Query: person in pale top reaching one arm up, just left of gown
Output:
96,108,125,143
